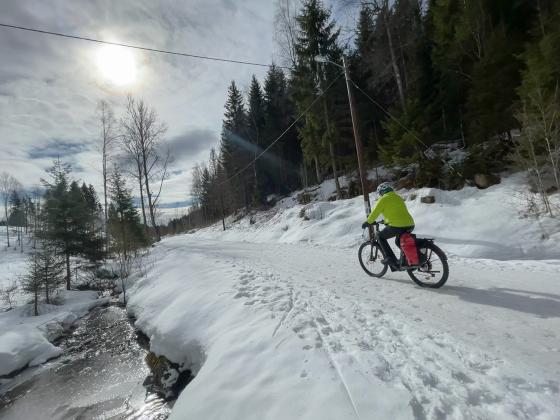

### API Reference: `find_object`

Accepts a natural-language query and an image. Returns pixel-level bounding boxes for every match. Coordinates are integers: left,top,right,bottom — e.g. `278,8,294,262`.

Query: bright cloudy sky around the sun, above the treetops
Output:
0,0,356,221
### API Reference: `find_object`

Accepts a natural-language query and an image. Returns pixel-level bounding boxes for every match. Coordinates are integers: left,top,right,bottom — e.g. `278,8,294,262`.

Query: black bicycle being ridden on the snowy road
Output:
358,221,449,289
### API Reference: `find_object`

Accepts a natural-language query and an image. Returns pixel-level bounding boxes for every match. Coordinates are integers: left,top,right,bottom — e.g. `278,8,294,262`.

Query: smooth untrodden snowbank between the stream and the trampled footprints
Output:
128,238,416,420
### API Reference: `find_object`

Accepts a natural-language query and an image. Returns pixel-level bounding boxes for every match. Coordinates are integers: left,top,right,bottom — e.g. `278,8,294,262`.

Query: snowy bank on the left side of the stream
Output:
0,291,108,375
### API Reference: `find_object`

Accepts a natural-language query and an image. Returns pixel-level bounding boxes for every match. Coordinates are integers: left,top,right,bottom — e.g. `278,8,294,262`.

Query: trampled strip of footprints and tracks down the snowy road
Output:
221,241,558,418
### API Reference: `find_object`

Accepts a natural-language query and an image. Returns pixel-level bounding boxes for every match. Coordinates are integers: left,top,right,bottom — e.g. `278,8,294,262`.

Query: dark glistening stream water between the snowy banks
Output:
0,306,171,420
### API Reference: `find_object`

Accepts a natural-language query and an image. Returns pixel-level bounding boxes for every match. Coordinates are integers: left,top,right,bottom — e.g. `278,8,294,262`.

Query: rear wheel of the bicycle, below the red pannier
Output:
407,242,449,289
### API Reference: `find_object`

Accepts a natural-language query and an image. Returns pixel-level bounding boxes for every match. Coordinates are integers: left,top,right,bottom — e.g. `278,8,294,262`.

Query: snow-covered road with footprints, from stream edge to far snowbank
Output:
130,235,560,420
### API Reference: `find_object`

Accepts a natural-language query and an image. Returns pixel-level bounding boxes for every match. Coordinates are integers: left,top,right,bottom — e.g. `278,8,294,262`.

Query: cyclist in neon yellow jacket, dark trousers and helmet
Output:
362,182,414,268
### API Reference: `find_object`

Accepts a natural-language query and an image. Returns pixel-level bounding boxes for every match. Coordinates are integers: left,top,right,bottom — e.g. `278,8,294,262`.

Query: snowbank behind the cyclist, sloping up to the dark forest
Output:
194,174,560,260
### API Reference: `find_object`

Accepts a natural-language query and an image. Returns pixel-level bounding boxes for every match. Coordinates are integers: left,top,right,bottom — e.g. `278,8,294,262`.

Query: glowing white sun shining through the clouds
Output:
96,45,137,86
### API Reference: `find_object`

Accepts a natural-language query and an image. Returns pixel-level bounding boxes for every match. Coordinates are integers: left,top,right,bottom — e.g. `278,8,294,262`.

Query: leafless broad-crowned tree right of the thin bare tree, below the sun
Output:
122,96,168,241
